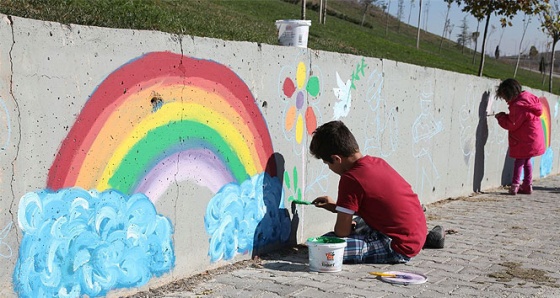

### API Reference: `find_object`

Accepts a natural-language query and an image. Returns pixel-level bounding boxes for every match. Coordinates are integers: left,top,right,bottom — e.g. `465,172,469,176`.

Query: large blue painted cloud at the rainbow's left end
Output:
13,188,175,297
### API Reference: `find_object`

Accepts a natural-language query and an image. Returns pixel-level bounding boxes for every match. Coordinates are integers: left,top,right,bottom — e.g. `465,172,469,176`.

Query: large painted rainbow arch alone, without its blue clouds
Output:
47,52,276,201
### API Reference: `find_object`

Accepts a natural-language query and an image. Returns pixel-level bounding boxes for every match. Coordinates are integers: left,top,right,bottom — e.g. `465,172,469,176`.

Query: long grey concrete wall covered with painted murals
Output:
0,15,560,297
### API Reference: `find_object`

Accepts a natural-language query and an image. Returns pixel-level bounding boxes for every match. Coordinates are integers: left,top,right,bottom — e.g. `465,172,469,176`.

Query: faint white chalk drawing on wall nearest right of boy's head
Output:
362,69,399,158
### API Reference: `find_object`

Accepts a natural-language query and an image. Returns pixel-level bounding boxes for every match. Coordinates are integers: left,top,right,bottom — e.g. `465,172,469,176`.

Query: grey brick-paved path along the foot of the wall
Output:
129,176,560,298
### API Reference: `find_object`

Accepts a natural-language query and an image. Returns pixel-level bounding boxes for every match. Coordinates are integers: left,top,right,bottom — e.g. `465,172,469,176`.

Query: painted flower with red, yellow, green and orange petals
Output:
282,62,319,144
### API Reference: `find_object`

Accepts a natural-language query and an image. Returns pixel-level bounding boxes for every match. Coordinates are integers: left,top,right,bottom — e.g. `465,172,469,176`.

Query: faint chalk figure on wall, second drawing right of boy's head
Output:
412,84,443,195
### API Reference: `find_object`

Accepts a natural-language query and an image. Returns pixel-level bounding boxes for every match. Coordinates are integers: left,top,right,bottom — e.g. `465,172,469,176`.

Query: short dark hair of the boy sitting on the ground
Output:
309,121,360,163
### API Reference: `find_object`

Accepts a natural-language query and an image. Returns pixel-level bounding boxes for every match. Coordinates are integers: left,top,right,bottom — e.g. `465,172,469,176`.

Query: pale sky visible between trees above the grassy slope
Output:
389,0,551,56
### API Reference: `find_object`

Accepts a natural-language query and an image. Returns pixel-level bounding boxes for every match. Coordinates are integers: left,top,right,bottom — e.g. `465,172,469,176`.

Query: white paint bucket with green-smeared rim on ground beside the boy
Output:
307,236,346,272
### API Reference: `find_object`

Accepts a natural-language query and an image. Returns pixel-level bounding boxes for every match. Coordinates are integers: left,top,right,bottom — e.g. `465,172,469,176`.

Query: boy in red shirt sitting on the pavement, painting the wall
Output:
309,121,444,264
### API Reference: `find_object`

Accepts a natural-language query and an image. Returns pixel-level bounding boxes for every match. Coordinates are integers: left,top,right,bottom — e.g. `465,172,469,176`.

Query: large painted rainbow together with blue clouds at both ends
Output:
13,52,291,297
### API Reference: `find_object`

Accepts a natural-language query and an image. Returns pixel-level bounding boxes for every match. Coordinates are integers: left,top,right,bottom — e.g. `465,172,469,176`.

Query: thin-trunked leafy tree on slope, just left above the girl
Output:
453,0,548,76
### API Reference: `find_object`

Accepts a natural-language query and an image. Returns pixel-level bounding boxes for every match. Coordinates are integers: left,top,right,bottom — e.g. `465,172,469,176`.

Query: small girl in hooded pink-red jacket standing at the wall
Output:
496,79,545,195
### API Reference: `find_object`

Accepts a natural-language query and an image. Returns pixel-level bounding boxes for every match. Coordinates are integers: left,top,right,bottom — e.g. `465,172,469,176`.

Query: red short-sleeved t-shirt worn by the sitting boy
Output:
336,155,428,257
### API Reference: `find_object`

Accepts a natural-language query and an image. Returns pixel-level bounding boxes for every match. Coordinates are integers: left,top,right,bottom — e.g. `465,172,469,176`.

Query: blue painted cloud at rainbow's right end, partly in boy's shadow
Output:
204,173,291,262
